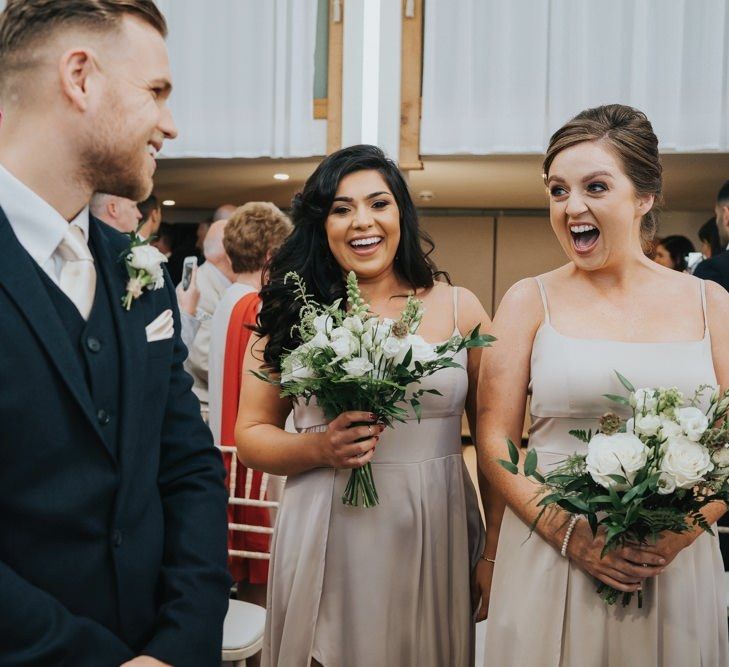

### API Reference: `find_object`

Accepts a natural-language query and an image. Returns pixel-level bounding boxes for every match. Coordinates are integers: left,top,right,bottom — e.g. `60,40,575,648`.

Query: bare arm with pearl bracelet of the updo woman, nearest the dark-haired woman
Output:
476,279,569,558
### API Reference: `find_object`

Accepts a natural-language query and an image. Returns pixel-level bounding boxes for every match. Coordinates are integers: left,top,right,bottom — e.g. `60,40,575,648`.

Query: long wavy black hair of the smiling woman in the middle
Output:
254,145,450,371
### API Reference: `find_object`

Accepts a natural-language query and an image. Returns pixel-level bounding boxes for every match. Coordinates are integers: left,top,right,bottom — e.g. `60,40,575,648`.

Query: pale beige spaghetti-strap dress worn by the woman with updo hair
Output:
485,279,729,667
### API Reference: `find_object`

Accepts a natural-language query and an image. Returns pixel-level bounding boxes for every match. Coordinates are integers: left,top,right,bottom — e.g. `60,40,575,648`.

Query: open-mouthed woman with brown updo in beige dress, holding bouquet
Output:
477,104,729,667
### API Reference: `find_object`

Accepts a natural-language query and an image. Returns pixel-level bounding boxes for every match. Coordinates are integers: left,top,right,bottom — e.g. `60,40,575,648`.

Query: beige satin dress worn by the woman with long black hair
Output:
262,290,483,667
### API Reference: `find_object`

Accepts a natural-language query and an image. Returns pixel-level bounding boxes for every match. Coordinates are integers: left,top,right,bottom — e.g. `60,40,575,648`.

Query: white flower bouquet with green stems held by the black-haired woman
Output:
255,272,494,507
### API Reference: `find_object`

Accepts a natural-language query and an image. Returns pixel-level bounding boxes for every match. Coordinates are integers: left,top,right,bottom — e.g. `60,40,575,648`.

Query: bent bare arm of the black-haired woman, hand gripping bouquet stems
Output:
235,335,383,475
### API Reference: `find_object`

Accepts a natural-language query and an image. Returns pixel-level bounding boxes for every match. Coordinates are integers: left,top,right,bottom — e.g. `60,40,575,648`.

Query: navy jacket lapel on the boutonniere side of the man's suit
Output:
89,217,146,466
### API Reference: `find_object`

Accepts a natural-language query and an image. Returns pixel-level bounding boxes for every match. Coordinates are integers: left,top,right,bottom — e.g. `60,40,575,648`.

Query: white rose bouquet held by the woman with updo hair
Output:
499,373,729,606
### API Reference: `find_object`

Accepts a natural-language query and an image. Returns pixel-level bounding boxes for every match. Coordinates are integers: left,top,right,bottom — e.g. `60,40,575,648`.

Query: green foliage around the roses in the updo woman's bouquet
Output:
499,373,729,605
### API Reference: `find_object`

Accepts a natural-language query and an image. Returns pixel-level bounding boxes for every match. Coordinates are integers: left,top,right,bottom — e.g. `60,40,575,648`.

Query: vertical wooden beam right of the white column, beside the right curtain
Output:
400,0,423,170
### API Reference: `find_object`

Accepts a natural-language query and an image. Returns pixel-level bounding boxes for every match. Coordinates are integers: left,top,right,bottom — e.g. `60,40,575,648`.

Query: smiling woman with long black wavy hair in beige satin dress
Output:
236,146,492,667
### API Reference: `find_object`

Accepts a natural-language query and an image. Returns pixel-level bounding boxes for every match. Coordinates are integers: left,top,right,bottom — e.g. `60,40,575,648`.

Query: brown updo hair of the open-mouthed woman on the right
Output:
542,104,663,248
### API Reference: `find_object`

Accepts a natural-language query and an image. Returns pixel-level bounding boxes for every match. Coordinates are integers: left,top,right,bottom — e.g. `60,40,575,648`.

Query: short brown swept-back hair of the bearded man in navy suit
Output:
0,0,167,91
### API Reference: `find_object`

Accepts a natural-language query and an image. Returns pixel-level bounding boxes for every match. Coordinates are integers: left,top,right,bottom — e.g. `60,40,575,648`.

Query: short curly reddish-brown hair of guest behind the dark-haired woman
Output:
223,202,293,273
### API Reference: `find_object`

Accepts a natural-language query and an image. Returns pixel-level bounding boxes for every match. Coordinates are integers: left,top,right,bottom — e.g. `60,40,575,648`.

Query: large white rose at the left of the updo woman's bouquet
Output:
585,433,648,491
